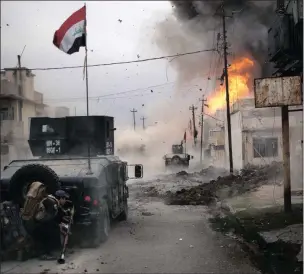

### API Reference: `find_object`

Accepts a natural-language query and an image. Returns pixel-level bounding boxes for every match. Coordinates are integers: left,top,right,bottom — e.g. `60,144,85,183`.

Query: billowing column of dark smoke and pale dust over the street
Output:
115,0,274,178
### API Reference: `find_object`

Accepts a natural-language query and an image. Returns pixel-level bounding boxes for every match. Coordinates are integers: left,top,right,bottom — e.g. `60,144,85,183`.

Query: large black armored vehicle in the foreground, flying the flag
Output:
0,116,143,246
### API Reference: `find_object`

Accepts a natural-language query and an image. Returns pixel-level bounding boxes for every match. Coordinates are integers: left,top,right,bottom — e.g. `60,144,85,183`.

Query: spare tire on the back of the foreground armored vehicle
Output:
9,164,60,206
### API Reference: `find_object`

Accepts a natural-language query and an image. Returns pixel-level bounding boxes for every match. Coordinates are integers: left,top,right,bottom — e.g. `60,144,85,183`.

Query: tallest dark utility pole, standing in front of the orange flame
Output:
218,4,233,173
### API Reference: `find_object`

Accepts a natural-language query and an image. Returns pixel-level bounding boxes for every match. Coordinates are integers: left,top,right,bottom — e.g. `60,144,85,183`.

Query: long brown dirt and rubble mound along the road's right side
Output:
165,163,280,205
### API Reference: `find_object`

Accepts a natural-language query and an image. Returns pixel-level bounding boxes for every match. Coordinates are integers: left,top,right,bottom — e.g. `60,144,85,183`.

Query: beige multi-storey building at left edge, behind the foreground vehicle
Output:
0,67,45,164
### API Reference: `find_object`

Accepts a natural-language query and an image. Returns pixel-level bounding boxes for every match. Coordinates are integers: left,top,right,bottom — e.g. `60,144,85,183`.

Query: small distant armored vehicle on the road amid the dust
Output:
163,143,193,167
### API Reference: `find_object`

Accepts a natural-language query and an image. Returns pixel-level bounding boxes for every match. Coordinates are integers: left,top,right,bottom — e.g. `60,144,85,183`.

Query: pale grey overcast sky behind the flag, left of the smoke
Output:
1,1,196,128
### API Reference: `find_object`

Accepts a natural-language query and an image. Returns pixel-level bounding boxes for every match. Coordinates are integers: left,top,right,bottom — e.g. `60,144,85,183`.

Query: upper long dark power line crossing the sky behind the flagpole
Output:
2,49,215,71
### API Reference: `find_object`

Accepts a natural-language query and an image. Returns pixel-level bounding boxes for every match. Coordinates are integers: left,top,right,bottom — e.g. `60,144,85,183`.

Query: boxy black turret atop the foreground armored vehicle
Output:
28,116,115,157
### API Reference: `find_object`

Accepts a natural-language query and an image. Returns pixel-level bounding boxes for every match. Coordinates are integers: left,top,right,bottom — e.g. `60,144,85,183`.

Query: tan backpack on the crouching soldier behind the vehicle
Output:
21,182,47,221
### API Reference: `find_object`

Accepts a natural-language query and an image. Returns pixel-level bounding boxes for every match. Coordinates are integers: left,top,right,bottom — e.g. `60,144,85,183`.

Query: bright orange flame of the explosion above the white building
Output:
208,57,254,113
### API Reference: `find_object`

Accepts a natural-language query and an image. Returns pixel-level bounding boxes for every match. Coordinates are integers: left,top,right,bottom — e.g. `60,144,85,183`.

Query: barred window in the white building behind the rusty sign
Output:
253,138,278,158
